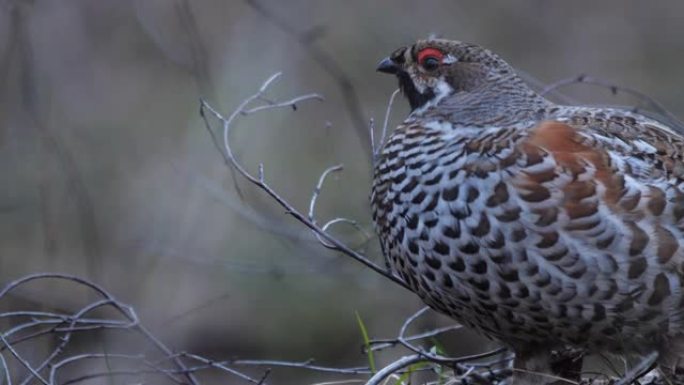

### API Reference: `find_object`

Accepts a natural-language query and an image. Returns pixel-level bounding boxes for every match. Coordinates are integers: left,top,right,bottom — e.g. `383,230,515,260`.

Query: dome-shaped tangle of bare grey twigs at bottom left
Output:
0,273,265,385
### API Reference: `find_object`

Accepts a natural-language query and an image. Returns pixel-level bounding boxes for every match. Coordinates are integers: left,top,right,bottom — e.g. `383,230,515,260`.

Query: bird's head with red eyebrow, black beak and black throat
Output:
377,39,515,110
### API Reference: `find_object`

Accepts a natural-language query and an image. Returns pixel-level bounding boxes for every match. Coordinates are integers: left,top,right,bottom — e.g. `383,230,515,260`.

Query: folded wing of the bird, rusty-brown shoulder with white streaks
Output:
510,117,684,328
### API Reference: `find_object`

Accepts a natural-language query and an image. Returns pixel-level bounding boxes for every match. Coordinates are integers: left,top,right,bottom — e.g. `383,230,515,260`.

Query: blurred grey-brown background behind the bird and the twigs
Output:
0,0,684,384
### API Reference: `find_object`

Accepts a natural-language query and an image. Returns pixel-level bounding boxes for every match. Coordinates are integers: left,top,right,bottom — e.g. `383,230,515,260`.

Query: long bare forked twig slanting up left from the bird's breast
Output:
200,73,410,290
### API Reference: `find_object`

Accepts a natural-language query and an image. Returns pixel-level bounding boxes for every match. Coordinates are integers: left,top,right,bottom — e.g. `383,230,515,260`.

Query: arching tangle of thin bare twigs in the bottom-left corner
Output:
0,273,254,385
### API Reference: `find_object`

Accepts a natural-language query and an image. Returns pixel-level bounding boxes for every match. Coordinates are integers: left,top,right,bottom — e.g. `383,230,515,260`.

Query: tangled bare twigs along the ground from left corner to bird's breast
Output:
0,273,508,385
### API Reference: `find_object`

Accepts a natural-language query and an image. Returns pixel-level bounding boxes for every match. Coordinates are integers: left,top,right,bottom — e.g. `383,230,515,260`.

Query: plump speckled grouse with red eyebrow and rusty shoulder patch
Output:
370,38,684,384
